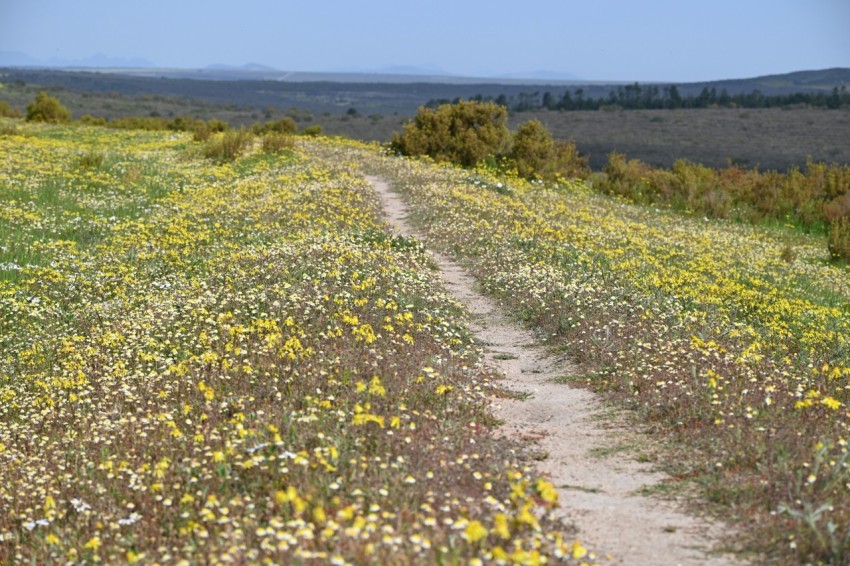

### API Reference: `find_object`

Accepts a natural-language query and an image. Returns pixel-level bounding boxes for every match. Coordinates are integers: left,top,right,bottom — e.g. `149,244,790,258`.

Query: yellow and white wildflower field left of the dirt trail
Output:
0,122,588,564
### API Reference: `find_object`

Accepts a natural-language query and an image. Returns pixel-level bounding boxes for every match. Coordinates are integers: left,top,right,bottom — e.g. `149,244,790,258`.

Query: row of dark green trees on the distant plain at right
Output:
425,83,850,112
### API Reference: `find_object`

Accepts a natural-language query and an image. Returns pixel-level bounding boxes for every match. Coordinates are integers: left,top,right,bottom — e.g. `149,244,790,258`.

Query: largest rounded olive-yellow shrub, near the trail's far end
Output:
390,101,511,167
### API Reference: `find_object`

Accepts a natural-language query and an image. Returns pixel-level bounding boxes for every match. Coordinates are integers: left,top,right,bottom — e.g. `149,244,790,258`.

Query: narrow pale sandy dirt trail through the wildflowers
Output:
368,177,739,566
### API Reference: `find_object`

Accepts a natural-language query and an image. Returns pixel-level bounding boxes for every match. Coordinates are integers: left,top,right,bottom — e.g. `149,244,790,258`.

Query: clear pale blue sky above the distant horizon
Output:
0,0,850,82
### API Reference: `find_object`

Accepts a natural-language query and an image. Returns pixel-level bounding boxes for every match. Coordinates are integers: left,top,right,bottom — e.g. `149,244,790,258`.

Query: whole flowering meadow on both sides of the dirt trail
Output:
6,117,850,563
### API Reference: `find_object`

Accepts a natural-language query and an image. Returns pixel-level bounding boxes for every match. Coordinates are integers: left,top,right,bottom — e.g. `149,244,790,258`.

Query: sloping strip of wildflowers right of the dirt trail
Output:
352,146,850,562
